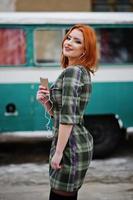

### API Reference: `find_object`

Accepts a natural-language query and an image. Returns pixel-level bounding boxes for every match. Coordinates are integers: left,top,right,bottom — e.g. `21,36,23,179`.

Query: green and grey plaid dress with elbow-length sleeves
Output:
49,66,93,192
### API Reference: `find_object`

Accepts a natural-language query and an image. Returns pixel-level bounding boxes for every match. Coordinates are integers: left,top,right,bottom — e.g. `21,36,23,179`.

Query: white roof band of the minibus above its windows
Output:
0,12,133,24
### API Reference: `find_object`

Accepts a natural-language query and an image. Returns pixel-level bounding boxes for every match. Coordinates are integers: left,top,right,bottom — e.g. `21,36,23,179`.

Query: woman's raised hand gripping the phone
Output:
36,85,49,105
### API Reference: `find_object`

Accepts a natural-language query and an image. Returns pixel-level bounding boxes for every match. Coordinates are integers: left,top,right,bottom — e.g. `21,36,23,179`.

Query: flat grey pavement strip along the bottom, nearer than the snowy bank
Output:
0,183,133,200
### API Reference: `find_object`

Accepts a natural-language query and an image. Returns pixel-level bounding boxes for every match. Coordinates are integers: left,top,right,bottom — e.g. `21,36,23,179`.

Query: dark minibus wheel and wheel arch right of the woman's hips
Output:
84,114,122,158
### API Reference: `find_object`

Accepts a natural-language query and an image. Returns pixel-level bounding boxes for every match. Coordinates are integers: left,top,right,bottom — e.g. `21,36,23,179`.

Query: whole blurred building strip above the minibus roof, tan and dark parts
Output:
0,0,133,12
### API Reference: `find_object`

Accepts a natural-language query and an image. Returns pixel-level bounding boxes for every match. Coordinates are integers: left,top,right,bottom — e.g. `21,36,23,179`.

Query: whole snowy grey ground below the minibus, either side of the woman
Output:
0,140,133,200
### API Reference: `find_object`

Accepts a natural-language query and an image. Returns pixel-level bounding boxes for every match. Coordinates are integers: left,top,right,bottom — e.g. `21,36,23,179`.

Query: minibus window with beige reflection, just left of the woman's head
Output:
35,30,62,63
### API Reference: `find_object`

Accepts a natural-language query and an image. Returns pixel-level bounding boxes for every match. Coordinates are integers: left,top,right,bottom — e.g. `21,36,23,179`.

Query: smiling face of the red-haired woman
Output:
63,29,84,65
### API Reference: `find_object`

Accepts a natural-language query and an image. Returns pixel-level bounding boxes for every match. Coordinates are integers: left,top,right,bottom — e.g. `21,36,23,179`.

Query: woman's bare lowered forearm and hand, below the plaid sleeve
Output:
51,124,73,169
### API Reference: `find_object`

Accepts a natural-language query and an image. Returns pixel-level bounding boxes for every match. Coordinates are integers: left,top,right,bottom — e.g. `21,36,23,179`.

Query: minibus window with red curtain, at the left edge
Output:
0,29,26,66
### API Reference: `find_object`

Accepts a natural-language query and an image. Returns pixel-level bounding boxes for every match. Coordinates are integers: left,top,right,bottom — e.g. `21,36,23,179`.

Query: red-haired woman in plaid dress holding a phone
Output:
37,24,97,200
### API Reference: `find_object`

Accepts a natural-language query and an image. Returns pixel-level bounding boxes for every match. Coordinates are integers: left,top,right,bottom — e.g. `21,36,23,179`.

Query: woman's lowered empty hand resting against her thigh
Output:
51,152,63,169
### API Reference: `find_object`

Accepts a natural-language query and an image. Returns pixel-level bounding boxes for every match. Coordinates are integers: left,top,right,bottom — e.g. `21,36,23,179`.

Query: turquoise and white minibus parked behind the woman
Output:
0,12,133,157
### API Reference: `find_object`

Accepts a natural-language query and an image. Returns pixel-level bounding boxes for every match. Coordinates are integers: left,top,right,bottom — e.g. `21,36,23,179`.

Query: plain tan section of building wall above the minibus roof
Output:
16,0,91,11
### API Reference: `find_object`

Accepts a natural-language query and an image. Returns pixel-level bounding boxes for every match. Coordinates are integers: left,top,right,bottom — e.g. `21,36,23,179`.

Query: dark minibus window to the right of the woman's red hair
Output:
97,28,133,64
